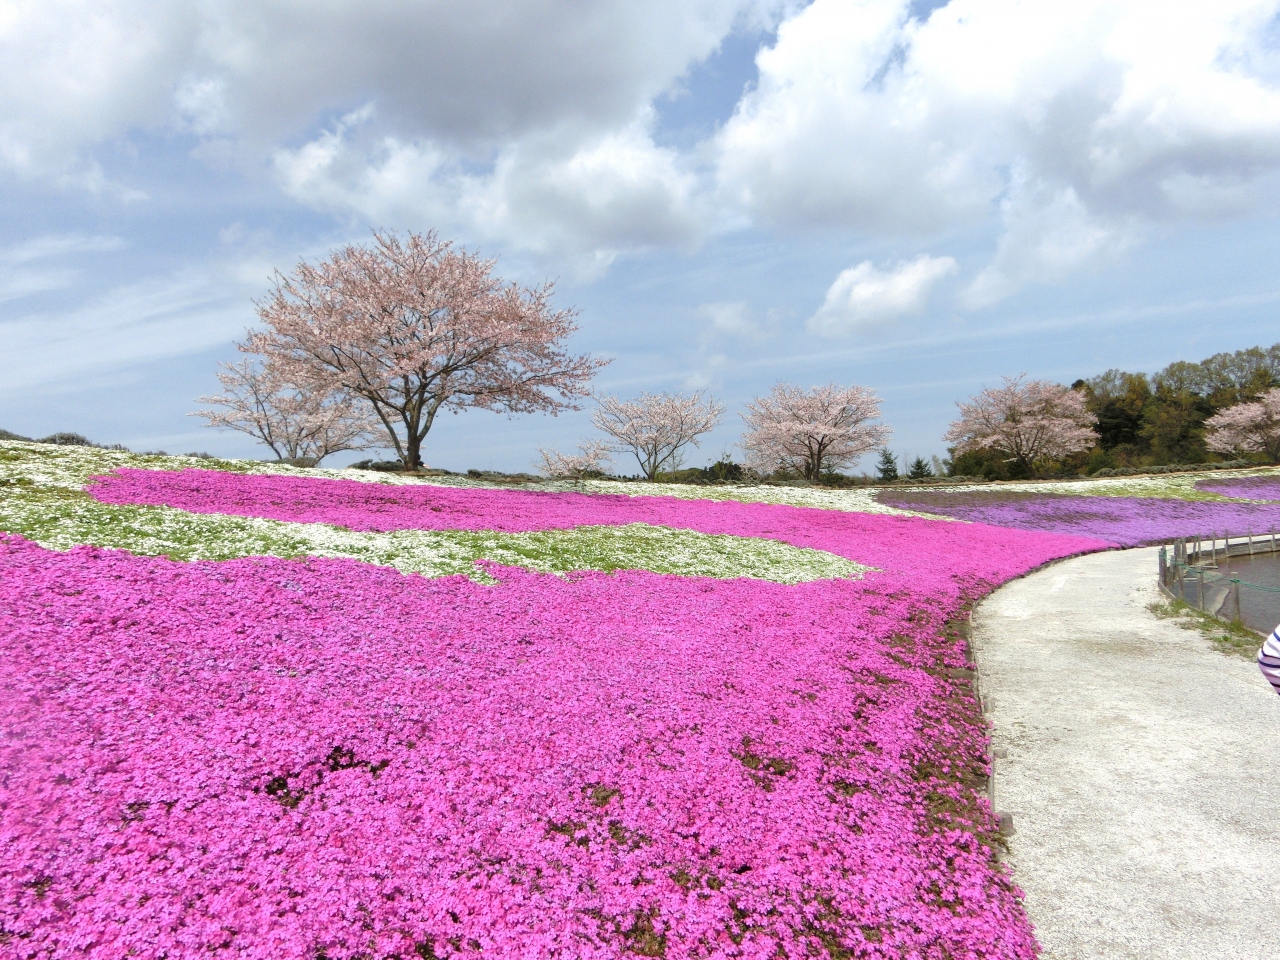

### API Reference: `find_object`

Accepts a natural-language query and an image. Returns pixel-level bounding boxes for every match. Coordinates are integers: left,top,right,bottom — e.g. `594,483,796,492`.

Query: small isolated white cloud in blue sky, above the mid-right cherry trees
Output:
808,255,957,337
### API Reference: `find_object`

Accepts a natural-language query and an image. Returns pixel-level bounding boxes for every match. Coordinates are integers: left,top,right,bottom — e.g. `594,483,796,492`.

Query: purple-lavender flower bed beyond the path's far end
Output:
878,490,1280,547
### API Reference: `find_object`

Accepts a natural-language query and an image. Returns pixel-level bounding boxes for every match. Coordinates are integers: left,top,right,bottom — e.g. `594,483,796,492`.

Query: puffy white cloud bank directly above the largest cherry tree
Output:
274,109,701,274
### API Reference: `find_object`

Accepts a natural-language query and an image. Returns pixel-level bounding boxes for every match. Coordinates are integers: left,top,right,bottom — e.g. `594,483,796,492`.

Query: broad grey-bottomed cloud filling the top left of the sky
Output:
0,0,757,173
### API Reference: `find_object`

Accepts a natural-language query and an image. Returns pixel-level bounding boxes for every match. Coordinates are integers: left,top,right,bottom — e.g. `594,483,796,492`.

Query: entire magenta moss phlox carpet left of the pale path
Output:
0,471,1108,960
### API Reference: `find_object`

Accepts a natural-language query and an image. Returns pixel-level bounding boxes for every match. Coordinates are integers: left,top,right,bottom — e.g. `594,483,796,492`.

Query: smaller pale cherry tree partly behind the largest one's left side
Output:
195,360,379,463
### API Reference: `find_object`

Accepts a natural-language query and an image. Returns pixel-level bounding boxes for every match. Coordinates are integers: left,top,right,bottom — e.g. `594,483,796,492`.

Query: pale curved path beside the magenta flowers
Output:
973,548,1280,960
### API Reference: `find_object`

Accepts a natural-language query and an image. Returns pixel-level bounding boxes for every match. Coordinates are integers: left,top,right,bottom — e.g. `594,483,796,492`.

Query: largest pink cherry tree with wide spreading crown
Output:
247,232,608,470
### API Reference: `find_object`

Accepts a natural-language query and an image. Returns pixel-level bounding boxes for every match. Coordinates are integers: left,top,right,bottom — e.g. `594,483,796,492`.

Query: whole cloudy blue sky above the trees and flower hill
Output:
0,0,1280,472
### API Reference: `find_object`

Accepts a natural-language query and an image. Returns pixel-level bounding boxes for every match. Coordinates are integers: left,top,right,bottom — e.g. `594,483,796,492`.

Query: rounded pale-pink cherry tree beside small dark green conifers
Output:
741,383,892,481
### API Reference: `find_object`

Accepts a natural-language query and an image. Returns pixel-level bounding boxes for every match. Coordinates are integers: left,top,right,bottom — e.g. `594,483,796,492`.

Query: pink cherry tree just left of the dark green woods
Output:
943,375,1098,475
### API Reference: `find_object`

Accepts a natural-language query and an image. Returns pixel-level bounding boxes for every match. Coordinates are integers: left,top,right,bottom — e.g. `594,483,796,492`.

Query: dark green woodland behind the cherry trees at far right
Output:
948,343,1280,480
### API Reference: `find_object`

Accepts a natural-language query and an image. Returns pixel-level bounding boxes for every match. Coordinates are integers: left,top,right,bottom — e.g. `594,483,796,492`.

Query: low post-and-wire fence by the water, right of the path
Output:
1160,530,1280,635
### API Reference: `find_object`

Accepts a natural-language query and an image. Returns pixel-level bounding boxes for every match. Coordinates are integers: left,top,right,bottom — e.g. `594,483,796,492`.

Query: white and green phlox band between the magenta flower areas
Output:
0,444,861,584
